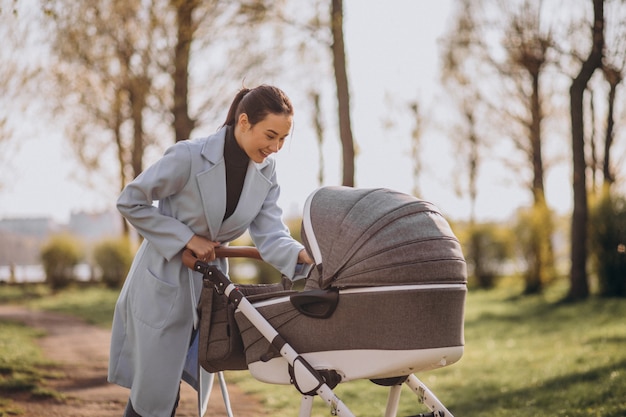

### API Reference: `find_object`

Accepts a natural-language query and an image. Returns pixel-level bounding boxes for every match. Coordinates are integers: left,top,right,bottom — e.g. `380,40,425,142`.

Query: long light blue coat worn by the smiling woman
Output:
108,129,303,417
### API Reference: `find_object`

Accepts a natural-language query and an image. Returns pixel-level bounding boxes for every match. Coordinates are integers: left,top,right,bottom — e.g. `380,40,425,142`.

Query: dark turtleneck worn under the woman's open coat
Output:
224,126,250,220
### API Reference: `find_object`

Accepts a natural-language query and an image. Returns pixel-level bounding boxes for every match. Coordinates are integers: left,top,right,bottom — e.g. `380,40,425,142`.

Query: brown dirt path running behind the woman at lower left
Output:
0,306,267,417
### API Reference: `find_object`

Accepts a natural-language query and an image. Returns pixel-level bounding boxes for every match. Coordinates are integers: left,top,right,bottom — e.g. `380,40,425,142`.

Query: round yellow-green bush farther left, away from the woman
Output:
40,235,83,290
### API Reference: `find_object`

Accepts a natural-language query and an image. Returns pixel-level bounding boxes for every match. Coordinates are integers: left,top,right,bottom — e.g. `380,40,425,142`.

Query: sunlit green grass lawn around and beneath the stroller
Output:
0,282,626,417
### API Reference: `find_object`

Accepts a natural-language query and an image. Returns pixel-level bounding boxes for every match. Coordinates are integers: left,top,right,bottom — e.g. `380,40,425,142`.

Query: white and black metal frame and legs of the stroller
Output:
194,261,453,417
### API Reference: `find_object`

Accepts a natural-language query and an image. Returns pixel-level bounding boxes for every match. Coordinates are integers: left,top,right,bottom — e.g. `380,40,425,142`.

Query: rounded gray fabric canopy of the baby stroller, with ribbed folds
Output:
302,186,467,288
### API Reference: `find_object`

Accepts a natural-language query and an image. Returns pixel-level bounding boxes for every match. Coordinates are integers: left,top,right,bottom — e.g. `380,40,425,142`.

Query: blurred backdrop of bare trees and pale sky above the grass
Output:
0,0,626,298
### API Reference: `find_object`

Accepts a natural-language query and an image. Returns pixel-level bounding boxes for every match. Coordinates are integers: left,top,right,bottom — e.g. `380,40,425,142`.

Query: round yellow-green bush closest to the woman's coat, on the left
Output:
93,238,133,288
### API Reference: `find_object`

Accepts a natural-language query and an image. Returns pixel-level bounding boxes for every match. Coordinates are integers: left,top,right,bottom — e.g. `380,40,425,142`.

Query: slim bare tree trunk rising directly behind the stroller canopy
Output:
331,0,354,187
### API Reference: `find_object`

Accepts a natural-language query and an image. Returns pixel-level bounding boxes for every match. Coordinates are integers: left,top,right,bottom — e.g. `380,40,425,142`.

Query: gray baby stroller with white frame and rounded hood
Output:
188,187,467,417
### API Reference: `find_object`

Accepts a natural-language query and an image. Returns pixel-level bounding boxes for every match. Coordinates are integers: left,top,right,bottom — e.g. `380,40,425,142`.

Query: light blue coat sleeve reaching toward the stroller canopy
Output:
249,167,304,279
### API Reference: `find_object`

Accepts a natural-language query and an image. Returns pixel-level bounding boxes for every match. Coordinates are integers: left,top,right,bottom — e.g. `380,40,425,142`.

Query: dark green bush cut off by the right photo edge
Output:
589,193,626,297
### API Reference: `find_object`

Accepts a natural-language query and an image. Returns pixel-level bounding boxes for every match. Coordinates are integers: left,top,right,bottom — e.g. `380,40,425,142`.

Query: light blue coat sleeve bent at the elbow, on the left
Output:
117,142,194,261
